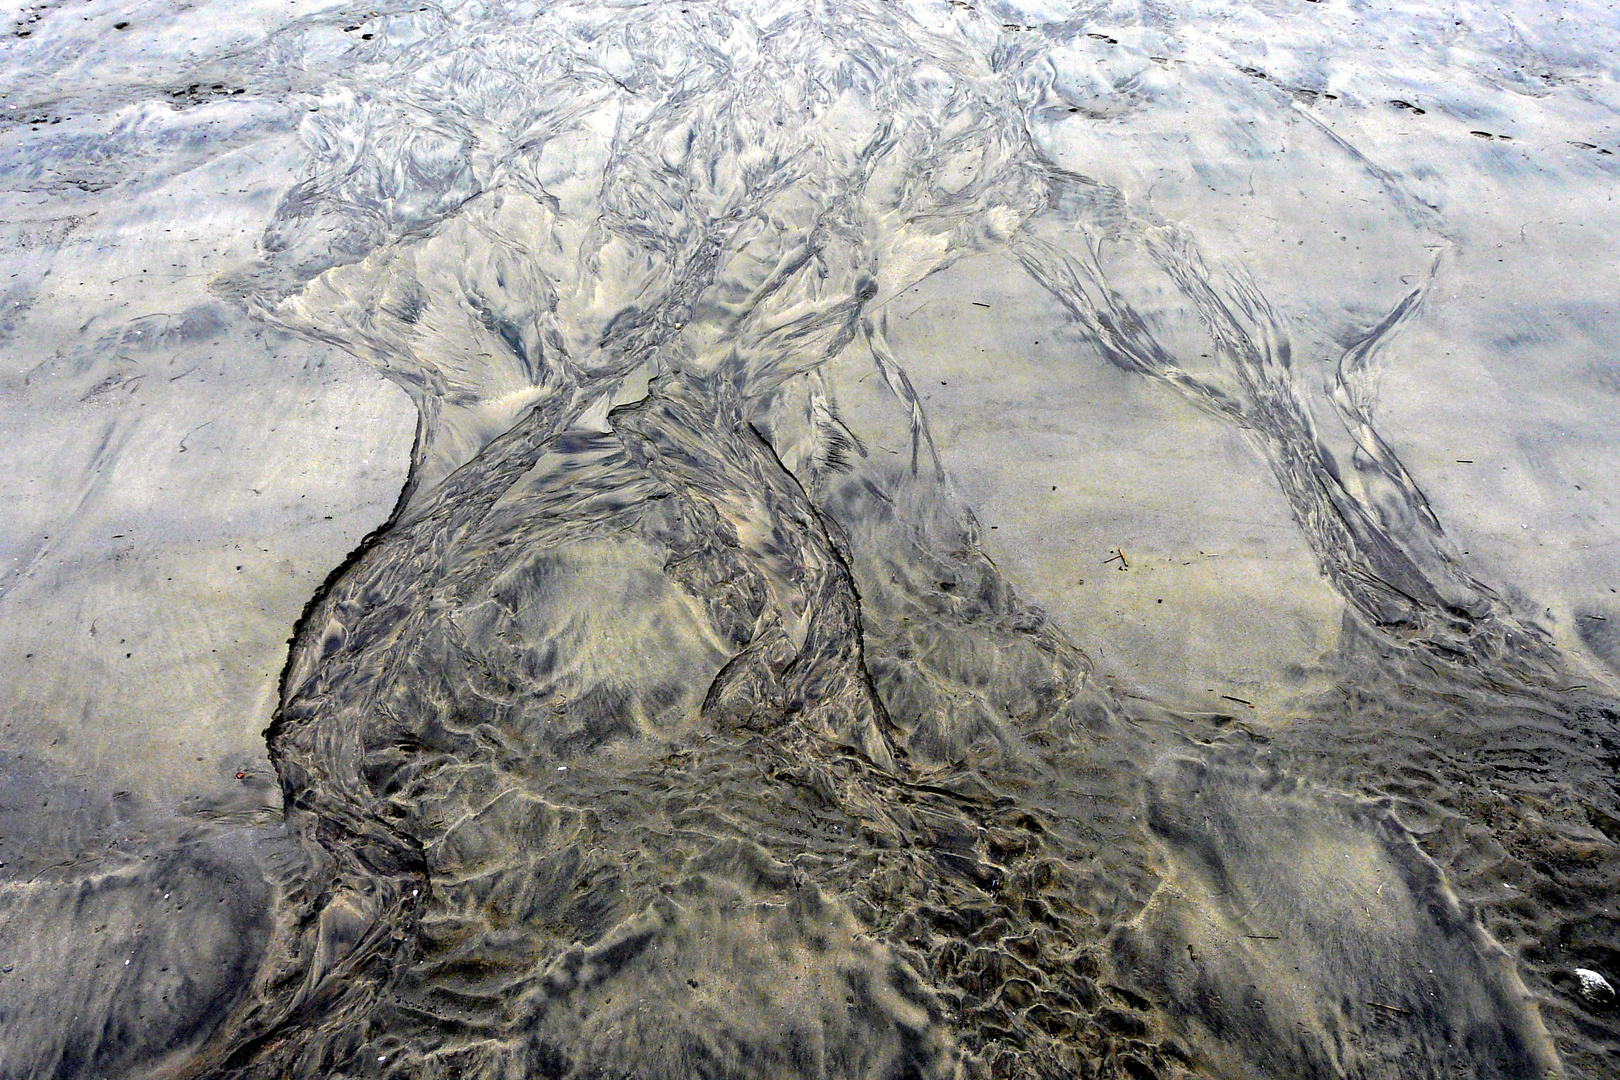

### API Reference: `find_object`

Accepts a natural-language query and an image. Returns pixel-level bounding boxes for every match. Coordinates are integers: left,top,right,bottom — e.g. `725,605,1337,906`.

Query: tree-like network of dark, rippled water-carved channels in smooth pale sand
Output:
0,0,1620,1080
